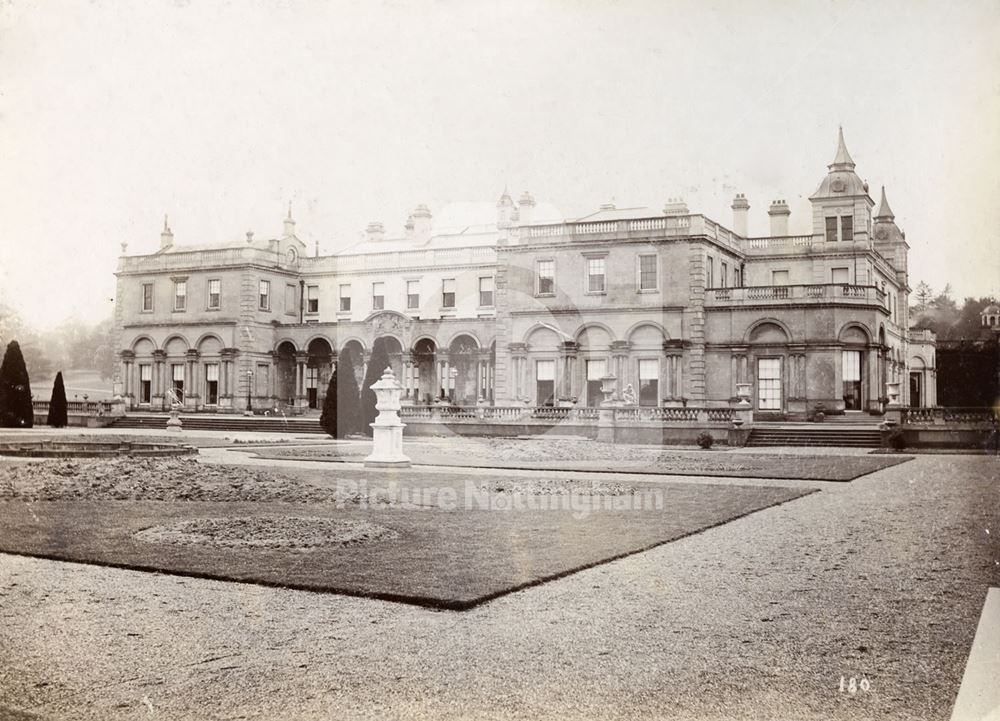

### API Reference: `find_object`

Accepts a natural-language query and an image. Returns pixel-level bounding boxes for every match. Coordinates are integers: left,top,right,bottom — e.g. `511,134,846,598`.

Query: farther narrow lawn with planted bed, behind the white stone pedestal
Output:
248,438,911,481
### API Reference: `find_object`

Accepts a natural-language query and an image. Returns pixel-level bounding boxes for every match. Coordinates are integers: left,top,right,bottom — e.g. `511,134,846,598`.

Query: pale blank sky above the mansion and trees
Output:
0,0,1000,326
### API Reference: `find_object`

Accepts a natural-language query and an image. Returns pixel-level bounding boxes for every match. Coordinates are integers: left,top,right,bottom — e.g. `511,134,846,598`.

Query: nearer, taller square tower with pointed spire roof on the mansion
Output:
809,128,875,243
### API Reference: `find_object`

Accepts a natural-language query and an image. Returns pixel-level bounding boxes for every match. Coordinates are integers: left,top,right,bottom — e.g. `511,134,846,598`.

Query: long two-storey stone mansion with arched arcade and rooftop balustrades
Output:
115,134,935,418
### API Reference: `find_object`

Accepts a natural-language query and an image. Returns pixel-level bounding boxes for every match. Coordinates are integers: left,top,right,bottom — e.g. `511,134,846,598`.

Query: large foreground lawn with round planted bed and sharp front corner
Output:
0,459,811,609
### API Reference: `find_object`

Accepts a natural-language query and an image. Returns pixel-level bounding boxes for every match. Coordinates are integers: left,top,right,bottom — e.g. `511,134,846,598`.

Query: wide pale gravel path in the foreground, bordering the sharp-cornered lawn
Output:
0,456,1000,721
